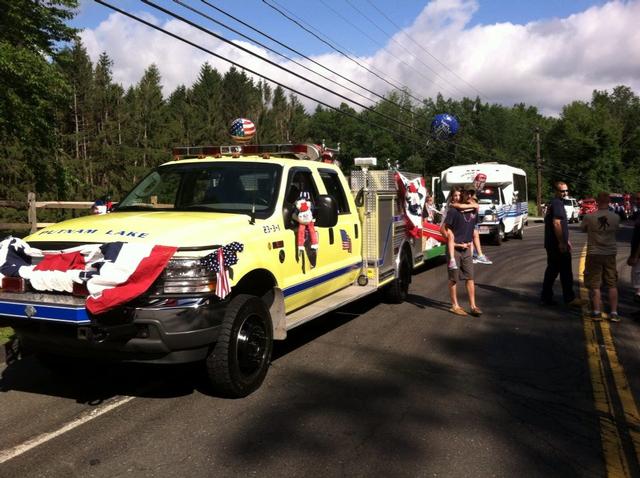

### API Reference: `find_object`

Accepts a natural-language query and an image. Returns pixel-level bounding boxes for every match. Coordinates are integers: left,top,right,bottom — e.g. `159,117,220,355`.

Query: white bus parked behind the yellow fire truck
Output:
434,163,529,245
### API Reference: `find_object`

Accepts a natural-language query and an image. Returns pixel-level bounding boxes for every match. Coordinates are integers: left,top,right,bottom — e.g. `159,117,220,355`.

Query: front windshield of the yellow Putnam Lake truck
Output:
117,161,282,217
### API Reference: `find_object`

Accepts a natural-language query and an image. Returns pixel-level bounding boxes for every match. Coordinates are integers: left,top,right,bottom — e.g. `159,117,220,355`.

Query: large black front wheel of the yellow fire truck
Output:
206,294,273,398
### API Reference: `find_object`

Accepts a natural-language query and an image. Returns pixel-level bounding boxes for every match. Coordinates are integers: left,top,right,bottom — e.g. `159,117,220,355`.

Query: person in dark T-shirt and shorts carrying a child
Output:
442,190,482,317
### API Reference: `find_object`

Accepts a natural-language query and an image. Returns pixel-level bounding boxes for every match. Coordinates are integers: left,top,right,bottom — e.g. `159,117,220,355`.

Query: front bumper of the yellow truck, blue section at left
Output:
0,293,224,363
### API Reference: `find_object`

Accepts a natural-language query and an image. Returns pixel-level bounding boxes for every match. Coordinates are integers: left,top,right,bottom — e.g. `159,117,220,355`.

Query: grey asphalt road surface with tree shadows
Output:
0,223,640,477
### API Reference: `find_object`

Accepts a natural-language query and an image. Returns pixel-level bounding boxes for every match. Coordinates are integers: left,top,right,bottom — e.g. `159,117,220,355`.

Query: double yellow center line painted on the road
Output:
578,245,640,477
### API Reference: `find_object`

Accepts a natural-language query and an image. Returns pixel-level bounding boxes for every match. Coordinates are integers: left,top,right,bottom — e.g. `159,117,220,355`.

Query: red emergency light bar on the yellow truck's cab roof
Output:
173,144,337,161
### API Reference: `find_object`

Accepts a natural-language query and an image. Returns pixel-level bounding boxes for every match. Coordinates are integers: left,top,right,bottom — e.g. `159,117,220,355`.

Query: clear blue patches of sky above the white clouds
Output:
73,0,605,55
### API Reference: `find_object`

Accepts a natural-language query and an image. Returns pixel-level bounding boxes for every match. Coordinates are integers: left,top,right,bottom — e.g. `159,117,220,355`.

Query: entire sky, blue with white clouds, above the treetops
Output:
74,0,640,115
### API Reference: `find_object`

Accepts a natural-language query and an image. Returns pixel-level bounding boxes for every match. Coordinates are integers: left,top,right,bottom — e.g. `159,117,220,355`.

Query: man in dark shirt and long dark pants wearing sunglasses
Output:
541,182,582,306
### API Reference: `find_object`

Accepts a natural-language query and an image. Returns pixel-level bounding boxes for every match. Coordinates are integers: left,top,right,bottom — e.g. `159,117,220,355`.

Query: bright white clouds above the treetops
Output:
82,0,640,114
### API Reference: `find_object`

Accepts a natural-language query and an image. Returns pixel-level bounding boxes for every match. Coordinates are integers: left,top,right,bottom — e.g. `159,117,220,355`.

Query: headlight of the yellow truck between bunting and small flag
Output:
162,257,216,294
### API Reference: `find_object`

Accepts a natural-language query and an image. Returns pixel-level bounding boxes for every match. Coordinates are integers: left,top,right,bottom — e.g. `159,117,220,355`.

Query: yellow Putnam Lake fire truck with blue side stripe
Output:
0,145,444,397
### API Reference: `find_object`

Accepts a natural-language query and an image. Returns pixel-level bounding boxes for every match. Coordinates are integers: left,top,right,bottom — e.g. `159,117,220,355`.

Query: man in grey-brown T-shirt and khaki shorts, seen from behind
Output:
580,192,620,322
